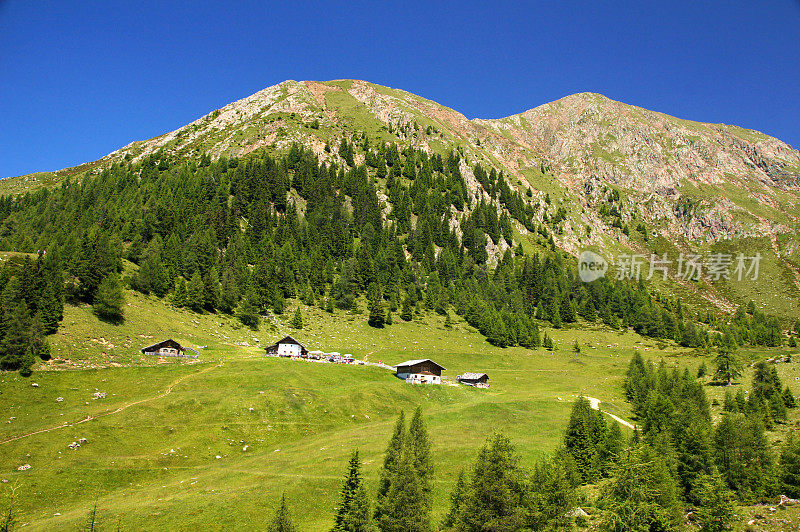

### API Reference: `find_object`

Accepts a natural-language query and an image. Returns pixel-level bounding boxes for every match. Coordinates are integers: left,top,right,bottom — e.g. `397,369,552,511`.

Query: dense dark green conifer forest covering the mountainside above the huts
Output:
0,141,782,369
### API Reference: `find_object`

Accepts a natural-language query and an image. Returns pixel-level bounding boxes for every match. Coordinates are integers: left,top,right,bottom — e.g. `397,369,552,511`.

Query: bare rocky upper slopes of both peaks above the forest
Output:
6,80,800,316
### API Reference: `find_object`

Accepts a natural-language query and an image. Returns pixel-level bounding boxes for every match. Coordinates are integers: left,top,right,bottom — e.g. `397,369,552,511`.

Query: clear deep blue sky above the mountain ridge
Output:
0,0,800,177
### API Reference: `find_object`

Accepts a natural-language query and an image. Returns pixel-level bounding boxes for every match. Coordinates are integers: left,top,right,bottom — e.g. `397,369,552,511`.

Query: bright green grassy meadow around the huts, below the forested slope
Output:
0,292,800,530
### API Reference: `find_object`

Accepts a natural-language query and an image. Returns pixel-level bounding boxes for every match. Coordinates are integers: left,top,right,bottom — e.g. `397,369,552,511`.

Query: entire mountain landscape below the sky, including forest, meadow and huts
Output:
0,80,800,532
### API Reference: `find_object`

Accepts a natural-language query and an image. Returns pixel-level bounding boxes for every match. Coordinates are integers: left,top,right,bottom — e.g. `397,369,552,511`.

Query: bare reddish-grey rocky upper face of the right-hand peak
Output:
480,93,800,192
